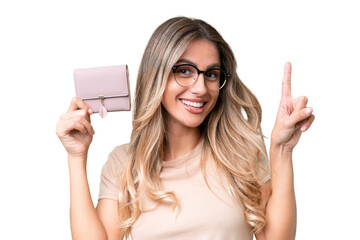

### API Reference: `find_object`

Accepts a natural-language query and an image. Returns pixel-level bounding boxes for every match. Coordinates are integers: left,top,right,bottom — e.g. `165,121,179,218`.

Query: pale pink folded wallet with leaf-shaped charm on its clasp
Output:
74,65,131,118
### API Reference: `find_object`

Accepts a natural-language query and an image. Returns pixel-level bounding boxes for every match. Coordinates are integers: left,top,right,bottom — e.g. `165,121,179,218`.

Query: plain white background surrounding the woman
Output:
0,0,360,240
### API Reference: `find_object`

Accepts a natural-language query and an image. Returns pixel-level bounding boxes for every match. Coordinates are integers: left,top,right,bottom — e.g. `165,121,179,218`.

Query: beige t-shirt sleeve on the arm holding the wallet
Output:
99,145,127,200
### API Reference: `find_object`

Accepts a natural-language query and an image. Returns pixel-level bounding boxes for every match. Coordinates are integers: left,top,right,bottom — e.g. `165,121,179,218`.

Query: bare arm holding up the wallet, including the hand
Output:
56,97,119,240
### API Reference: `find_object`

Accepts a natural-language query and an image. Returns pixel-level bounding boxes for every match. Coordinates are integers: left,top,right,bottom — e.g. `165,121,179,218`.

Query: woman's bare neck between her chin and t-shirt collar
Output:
164,124,201,161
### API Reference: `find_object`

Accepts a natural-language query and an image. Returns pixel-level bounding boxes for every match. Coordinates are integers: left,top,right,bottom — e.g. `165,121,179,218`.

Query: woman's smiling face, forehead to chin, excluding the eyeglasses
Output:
162,39,220,128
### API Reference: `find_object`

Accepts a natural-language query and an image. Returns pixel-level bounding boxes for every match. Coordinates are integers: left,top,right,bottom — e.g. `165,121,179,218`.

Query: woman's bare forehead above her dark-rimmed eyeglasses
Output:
178,39,220,68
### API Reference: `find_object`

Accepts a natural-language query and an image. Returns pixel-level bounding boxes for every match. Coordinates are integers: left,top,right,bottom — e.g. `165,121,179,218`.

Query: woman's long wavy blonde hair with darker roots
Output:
119,17,267,237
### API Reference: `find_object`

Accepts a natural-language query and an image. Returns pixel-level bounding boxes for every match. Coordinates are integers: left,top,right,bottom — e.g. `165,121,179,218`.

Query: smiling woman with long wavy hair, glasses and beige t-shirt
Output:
57,17,314,240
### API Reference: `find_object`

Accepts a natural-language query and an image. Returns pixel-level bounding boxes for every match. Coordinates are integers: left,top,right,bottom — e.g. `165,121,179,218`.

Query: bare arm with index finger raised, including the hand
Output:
256,63,315,240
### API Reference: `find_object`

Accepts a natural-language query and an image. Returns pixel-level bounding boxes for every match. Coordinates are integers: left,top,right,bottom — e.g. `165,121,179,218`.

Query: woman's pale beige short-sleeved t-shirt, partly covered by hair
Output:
99,141,268,240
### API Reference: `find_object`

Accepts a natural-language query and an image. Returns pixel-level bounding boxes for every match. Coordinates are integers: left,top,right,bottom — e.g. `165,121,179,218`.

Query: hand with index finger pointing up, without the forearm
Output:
271,62,315,152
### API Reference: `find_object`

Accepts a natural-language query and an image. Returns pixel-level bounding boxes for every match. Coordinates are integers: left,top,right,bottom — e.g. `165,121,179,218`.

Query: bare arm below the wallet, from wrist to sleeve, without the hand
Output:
69,159,122,240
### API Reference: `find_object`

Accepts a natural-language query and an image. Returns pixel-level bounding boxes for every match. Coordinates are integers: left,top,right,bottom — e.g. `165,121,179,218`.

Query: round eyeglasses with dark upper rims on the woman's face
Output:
172,64,231,91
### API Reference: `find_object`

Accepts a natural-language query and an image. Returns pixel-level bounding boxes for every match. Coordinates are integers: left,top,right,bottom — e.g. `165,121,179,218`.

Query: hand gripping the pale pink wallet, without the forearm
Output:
56,97,95,159
